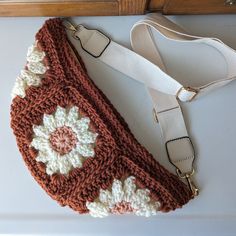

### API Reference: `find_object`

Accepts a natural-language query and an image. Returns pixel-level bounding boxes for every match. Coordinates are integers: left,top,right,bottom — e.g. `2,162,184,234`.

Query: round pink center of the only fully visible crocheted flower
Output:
49,126,78,155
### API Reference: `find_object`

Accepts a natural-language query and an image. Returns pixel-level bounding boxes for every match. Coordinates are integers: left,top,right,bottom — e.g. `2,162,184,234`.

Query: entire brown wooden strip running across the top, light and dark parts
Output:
0,0,236,16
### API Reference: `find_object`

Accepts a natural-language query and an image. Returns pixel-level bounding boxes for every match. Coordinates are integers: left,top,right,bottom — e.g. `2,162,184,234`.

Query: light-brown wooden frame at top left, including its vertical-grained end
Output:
0,0,148,16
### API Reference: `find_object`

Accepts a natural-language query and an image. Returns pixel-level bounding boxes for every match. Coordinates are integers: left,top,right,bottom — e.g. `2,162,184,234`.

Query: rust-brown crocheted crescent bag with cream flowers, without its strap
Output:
11,18,191,217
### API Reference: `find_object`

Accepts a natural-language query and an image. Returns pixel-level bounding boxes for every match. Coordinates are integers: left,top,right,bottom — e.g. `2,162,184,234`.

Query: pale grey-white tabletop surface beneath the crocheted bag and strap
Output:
0,15,236,235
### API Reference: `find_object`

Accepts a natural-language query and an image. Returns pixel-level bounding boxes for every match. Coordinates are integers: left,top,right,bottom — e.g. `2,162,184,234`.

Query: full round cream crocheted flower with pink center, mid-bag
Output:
31,106,98,175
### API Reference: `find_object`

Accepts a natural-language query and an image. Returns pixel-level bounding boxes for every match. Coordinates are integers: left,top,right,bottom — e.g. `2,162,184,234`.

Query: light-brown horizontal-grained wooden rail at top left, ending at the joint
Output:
0,1,119,16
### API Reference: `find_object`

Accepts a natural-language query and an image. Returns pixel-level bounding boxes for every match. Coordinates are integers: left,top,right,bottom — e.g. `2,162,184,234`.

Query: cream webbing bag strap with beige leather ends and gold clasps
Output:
65,14,236,195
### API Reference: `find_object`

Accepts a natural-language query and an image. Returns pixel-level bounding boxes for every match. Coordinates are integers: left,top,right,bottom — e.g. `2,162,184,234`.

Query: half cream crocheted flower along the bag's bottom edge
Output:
86,176,160,218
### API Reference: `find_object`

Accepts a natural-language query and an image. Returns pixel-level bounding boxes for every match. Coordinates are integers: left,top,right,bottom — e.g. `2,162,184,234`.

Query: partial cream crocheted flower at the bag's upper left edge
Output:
12,41,47,98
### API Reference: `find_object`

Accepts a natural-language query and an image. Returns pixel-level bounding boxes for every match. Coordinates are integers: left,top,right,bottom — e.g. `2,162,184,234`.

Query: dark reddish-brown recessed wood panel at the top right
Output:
163,0,236,14
